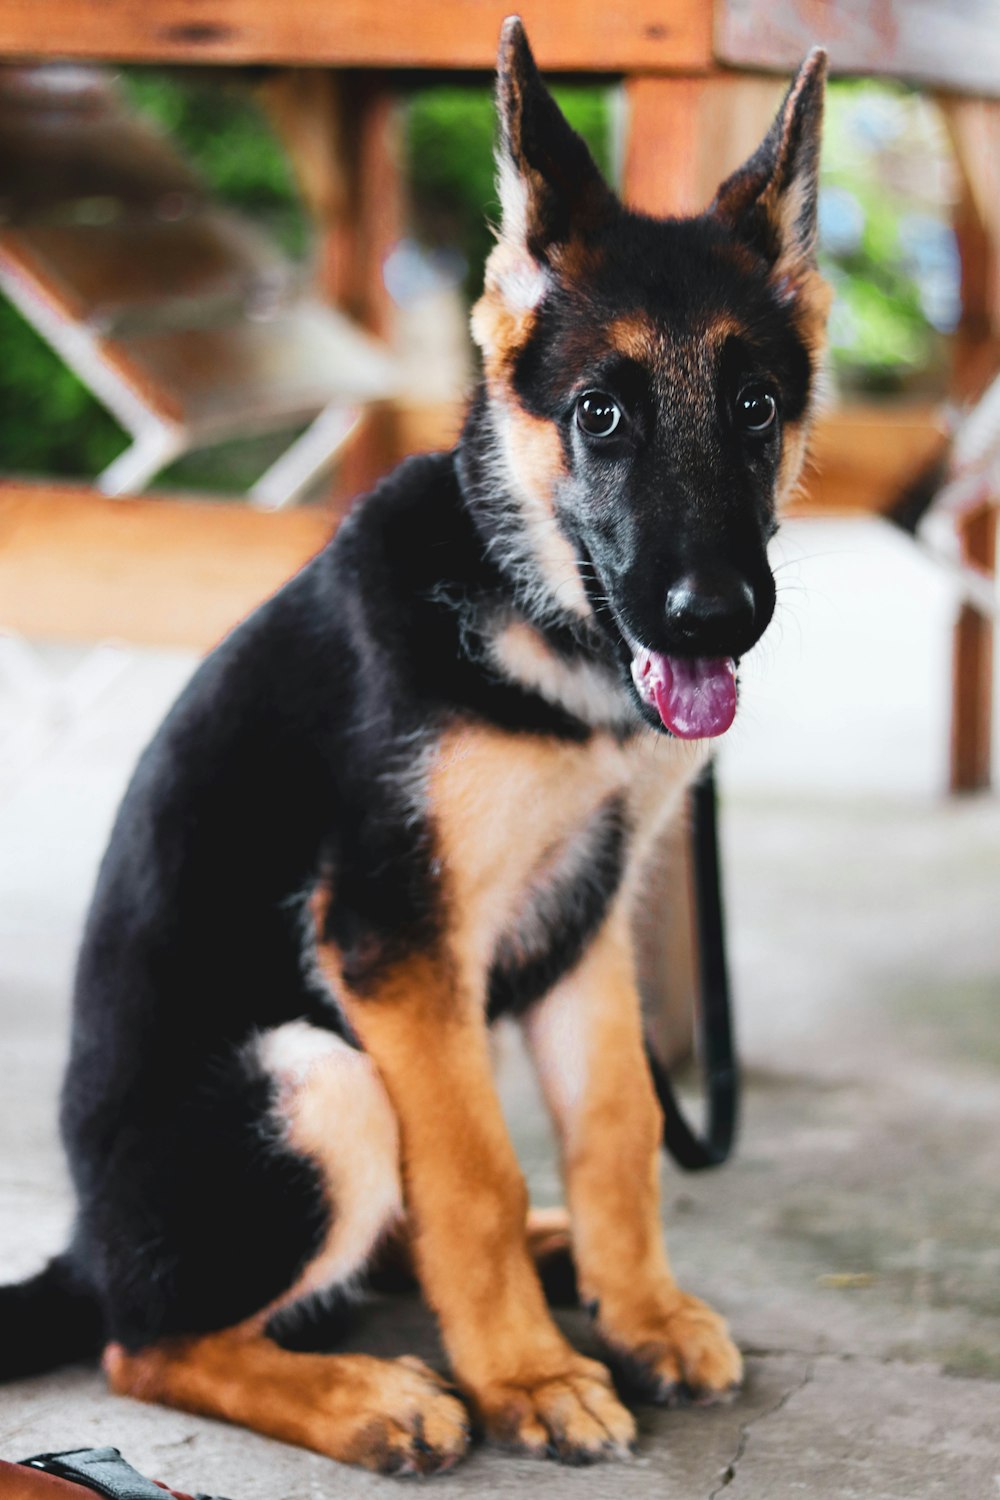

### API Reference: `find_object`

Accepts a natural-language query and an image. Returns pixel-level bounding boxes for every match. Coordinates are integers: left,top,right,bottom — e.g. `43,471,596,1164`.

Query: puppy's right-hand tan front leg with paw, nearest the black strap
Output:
525,903,742,1403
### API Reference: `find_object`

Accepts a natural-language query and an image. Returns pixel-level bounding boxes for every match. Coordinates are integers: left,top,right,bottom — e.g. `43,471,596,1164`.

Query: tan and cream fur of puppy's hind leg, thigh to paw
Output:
105,1022,469,1473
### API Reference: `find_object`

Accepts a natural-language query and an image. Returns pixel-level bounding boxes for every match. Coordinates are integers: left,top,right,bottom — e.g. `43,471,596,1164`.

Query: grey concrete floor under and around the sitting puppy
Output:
0,653,1000,1500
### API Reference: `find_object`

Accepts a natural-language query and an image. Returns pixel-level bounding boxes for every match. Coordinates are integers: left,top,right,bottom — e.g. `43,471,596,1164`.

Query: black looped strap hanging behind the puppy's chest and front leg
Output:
646,762,739,1172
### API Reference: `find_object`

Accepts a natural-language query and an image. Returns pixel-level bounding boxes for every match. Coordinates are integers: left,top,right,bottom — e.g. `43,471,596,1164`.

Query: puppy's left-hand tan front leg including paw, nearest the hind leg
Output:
333,956,634,1463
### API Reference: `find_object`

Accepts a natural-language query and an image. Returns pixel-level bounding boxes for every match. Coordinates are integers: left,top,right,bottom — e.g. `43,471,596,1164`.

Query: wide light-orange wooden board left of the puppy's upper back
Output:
0,482,333,650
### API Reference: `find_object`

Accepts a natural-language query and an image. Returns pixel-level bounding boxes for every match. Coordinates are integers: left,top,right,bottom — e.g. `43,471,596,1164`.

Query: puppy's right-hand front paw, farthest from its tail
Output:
598,1292,744,1406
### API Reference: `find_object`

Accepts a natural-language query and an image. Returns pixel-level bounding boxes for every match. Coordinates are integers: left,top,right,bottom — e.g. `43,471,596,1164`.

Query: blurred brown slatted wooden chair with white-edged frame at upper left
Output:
0,66,397,509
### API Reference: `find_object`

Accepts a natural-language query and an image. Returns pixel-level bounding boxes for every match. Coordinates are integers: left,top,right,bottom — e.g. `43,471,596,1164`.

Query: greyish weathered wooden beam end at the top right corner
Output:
715,0,1000,99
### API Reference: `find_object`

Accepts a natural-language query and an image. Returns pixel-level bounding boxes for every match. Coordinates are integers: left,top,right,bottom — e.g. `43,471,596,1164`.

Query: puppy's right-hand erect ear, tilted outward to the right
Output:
711,47,826,279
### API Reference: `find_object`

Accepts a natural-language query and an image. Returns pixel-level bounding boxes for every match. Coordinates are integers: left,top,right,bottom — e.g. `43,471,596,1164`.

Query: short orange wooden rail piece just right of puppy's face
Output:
789,402,946,516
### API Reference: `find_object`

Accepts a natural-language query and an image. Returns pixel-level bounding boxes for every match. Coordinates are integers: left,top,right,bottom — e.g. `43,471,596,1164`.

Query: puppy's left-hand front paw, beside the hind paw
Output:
472,1355,636,1464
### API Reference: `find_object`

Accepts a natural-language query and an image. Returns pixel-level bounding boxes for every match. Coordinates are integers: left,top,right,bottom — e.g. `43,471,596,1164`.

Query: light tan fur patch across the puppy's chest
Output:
427,726,706,990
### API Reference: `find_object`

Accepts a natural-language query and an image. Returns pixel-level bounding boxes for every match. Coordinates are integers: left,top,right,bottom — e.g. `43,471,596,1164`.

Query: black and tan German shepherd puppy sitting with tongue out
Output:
0,18,828,1473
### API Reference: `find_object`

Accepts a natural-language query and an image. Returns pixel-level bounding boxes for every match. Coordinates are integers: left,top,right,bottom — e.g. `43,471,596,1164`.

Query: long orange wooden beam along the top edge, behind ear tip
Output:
0,0,712,72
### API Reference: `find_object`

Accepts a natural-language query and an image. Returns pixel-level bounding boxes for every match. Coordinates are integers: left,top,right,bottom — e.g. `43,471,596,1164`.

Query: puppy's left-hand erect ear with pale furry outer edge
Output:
496,15,616,263
